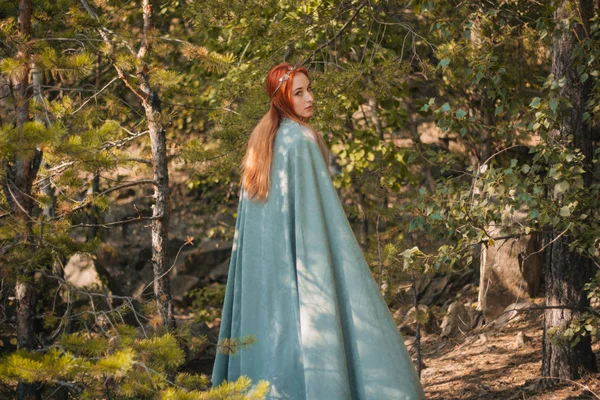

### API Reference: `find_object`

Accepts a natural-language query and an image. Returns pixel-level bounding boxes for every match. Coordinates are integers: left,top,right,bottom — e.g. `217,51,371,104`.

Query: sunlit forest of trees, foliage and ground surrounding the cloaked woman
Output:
0,0,600,400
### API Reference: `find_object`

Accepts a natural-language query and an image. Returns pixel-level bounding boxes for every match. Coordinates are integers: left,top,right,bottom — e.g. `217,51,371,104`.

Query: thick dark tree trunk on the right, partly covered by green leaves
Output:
542,0,596,379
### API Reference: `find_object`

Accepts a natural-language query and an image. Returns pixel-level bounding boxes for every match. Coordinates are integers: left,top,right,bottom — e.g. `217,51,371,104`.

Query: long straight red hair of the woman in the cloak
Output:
241,63,329,202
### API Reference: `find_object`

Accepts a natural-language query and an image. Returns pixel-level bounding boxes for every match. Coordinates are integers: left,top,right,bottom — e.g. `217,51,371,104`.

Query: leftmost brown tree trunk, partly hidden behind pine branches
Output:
8,0,42,400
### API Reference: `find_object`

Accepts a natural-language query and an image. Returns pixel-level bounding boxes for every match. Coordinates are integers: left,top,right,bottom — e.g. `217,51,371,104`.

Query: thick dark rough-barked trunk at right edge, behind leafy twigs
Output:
542,0,597,379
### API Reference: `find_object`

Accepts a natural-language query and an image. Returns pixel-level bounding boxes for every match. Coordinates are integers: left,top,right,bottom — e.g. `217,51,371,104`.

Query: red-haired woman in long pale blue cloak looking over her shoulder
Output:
212,63,424,400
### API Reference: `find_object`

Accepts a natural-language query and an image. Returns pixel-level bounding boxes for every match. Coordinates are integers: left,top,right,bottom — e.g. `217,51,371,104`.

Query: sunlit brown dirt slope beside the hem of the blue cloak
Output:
418,313,600,400
